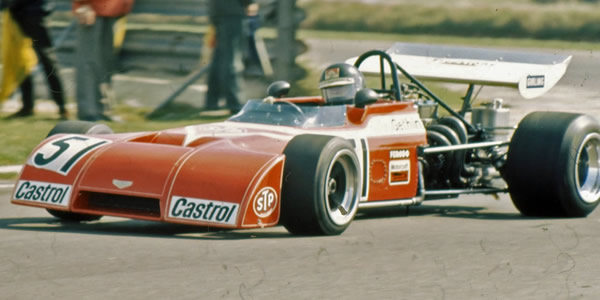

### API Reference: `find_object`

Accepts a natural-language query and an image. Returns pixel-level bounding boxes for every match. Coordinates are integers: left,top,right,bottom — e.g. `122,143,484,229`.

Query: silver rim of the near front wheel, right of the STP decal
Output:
325,150,360,225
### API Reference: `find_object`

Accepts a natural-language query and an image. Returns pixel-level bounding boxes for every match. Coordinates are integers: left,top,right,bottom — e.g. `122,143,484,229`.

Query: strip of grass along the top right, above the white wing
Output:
299,1,600,41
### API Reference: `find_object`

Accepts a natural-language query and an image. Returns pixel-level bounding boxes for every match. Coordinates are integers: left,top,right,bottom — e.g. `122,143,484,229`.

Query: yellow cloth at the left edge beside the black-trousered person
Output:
0,10,37,103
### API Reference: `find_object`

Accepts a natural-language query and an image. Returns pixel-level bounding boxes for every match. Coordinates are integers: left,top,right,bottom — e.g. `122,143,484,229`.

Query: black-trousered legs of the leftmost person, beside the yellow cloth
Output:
3,0,67,119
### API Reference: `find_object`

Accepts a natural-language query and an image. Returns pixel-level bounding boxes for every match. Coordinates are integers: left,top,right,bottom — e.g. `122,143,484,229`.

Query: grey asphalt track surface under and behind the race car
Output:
0,42,600,299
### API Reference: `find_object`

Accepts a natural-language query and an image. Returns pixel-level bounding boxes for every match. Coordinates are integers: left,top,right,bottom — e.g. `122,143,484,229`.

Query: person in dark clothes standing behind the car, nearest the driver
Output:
206,0,253,114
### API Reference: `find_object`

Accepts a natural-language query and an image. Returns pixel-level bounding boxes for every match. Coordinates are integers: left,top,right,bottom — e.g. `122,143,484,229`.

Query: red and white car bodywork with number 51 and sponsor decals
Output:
12,97,426,228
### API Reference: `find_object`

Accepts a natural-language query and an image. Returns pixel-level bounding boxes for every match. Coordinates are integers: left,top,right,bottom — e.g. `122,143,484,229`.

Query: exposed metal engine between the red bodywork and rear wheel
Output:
418,99,514,190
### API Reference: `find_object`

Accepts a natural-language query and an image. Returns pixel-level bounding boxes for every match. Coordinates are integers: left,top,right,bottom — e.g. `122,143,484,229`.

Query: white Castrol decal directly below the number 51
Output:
13,180,73,207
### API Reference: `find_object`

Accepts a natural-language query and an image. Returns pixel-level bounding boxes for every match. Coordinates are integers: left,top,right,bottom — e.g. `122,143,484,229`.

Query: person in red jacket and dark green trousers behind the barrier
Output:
73,0,134,121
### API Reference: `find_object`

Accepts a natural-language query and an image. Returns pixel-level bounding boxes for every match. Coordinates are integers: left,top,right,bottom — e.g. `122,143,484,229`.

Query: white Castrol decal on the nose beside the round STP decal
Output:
169,196,239,225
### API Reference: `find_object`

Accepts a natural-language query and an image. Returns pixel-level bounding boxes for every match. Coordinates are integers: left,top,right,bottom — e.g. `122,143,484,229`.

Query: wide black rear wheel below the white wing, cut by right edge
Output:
502,112,600,217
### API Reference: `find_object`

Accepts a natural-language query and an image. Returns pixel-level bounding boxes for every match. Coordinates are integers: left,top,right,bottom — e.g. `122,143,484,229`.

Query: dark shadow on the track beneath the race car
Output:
0,200,531,240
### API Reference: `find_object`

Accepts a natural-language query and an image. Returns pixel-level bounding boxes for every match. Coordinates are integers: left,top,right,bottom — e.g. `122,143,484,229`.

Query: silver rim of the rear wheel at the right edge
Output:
575,133,600,203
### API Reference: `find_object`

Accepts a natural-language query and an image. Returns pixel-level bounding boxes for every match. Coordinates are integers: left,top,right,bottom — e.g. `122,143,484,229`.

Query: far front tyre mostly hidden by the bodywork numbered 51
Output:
46,121,113,222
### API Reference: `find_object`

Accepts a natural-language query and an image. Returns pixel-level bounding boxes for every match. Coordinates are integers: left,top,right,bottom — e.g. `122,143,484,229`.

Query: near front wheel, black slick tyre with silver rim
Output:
281,135,361,235
